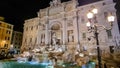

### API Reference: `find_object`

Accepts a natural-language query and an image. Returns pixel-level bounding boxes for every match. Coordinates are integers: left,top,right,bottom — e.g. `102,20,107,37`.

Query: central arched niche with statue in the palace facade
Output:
51,22,62,45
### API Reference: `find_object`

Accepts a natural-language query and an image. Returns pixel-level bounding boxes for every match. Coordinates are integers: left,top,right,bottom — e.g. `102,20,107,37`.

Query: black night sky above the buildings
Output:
0,0,120,32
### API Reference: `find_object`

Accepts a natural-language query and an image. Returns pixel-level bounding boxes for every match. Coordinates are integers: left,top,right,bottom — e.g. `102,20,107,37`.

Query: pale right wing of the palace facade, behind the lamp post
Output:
78,0,120,50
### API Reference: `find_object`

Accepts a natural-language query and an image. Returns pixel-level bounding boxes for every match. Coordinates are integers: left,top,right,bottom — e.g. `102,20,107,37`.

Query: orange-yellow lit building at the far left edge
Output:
0,21,13,53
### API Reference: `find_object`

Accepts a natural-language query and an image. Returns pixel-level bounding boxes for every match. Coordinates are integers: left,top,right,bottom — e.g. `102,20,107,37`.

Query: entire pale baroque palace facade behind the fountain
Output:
21,0,120,52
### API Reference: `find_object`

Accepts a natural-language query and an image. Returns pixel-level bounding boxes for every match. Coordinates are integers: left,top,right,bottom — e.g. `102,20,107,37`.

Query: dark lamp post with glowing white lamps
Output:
86,8,114,68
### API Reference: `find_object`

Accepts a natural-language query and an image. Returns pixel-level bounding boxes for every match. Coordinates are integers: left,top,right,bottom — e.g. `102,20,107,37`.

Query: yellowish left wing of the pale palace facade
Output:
21,18,40,51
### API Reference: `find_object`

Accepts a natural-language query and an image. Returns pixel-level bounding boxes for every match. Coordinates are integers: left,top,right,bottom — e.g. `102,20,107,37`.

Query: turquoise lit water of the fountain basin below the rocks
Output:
0,61,95,68
